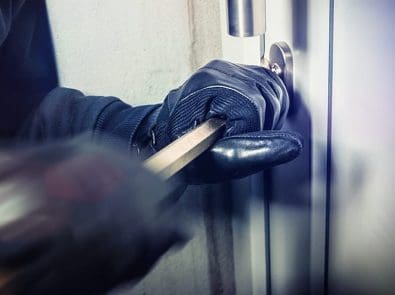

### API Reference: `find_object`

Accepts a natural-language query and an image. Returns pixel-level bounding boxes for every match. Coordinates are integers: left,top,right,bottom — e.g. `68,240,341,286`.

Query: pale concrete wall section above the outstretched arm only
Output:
47,0,221,104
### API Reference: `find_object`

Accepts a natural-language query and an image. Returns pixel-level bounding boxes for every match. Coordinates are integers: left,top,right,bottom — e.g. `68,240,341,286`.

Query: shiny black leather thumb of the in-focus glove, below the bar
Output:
184,131,303,184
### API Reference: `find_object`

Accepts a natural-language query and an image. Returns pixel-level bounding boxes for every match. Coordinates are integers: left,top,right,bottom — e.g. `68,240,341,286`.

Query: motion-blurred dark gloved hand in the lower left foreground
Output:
0,141,187,294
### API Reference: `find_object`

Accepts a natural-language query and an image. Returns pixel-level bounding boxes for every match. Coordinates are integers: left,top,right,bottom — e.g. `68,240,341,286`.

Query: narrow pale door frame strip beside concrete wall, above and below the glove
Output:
220,0,267,295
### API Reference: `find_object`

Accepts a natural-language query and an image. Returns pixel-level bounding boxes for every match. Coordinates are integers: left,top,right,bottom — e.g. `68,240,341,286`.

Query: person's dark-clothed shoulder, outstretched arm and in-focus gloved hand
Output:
0,0,302,182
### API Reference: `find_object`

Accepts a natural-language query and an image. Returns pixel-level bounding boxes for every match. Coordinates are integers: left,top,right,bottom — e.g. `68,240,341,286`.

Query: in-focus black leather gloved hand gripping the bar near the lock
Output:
137,60,302,183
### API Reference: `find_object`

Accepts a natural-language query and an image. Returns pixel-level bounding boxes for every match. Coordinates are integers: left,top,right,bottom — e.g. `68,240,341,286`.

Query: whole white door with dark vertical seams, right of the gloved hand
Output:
224,0,395,294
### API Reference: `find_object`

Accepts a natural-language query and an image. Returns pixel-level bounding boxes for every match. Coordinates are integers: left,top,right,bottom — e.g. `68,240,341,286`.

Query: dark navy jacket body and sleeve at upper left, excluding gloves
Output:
0,0,160,146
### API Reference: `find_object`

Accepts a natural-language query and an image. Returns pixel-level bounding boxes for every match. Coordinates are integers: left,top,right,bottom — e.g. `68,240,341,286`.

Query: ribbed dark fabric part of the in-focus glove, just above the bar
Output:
155,85,266,149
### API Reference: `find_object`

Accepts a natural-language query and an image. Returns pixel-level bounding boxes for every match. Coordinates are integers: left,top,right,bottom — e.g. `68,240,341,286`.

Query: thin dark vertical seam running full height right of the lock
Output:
324,0,335,294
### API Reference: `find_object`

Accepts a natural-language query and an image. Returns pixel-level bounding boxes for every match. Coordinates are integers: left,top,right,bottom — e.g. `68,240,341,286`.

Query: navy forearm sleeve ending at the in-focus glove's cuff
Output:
19,88,159,149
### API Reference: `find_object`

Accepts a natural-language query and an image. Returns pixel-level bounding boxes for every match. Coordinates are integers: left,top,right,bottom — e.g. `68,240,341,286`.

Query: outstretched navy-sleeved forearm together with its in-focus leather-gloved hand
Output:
19,61,302,183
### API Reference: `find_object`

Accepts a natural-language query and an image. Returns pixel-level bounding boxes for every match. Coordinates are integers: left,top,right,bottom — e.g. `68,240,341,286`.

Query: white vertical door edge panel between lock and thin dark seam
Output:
265,0,330,294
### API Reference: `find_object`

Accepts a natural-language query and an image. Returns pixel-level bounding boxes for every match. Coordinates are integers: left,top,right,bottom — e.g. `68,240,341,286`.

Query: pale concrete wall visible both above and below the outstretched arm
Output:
47,0,224,294
